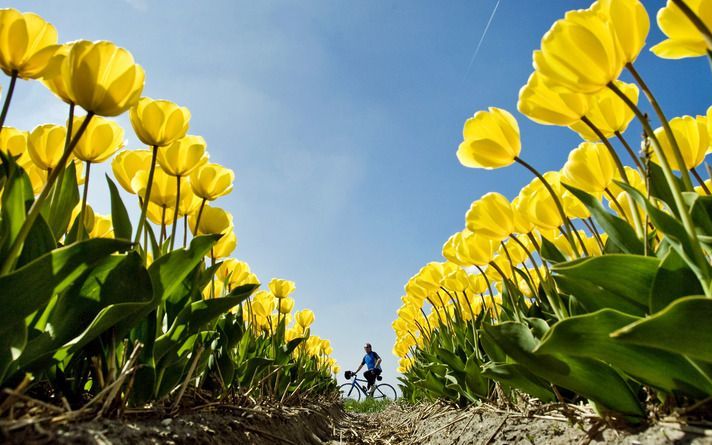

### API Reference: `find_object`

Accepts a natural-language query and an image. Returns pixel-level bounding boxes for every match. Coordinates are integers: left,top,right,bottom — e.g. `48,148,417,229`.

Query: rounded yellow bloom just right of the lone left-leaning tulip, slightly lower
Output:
561,142,617,193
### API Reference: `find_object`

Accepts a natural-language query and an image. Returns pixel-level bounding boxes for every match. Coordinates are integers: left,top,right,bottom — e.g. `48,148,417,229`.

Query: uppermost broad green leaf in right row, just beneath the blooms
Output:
552,254,660,315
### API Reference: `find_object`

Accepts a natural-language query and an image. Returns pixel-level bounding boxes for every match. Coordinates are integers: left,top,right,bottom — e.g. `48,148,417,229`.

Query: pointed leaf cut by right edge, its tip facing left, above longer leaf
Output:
611,296,712,362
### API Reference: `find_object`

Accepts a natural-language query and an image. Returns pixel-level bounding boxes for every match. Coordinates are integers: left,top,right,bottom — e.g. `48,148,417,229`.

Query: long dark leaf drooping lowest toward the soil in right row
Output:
483,322,644,420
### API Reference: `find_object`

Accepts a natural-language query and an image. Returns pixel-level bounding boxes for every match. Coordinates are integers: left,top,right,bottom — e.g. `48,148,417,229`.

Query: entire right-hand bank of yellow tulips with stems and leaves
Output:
393,0,712,430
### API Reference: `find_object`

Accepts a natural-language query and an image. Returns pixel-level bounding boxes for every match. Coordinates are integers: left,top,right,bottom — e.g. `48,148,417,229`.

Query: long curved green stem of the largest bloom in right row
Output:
608,82,712,297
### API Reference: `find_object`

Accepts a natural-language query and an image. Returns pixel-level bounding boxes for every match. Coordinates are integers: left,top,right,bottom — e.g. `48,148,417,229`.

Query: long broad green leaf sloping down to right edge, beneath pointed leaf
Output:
535,309,712,396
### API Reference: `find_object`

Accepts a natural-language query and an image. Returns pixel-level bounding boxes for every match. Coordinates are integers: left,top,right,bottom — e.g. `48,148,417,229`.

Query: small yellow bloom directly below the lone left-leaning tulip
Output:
465,192,514,241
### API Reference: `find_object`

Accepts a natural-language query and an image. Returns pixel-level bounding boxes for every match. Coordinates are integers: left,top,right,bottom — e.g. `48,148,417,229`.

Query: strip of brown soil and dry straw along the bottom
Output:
5,403,712,445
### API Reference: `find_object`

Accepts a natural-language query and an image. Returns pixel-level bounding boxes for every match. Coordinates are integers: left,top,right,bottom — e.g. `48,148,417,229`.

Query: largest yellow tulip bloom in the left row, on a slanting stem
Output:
60,40,144,116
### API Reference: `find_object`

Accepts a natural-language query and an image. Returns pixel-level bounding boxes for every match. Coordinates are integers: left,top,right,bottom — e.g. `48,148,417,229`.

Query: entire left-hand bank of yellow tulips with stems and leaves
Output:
0,5,338,434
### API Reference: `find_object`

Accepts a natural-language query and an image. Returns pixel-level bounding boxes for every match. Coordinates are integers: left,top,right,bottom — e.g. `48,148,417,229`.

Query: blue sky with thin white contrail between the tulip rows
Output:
2,0,712,380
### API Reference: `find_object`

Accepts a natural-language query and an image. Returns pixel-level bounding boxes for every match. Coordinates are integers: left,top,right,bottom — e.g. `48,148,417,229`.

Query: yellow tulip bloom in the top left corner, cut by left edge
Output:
0,9,58,79
